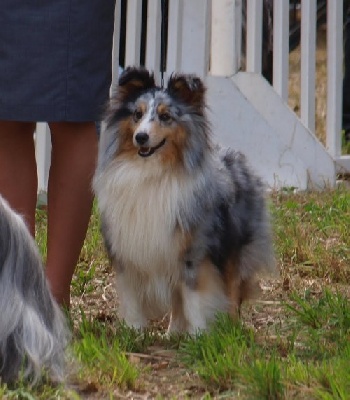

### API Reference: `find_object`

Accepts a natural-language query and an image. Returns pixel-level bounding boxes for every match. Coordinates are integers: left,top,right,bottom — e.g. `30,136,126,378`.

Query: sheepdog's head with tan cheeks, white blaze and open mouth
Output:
107,67,209,168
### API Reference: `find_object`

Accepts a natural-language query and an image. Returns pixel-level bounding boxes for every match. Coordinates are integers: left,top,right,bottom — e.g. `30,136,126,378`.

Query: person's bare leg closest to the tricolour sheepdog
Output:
46,122,97,307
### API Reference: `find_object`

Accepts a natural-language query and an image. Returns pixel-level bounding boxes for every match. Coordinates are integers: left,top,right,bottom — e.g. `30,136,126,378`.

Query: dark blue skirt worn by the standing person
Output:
0,0,115,122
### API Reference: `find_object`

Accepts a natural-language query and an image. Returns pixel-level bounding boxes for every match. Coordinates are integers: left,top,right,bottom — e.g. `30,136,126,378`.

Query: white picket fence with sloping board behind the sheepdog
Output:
37,0,350,197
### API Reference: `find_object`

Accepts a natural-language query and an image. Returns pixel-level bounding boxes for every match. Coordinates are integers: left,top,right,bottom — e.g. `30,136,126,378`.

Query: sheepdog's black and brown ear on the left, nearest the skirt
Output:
117,67,155,101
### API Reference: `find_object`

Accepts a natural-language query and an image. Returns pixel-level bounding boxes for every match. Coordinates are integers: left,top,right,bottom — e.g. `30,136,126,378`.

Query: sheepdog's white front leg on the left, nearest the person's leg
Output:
117,269,147,329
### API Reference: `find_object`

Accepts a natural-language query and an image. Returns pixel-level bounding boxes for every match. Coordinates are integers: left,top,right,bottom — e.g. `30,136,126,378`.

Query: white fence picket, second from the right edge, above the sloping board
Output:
300,0,317,132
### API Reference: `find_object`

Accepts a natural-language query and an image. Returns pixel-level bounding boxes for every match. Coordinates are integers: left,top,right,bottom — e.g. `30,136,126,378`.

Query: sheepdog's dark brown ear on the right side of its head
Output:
168,75,205,112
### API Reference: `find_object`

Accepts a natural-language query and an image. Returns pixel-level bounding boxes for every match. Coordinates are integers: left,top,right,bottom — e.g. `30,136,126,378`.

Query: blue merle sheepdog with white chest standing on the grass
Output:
94,68,274,333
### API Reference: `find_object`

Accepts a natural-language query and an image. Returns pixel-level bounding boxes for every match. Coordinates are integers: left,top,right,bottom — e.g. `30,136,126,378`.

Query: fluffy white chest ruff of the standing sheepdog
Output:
98,163,191,274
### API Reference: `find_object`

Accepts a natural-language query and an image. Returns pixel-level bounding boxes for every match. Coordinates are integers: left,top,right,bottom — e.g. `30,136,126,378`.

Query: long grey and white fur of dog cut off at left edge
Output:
0,197,69,382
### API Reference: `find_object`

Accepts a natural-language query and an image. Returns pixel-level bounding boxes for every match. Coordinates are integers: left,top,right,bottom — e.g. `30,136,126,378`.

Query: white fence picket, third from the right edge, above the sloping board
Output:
273,0,289,102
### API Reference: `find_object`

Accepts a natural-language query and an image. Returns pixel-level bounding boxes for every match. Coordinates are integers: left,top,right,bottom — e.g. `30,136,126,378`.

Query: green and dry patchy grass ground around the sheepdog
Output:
0,188,350,399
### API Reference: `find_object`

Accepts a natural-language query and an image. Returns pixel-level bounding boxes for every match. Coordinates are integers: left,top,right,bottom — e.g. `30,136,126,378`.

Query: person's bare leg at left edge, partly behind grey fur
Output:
0,121,38,236
